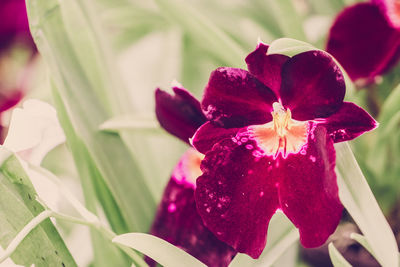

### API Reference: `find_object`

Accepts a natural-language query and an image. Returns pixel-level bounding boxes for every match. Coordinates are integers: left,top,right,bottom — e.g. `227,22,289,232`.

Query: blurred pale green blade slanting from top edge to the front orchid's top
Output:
155,0,246,67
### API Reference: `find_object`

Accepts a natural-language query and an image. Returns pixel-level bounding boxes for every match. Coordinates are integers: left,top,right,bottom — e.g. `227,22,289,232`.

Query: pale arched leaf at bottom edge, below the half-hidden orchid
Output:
113,233,206,267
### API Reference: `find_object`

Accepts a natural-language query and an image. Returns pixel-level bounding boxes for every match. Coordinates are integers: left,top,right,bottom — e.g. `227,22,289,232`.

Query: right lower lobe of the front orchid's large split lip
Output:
276,126,343,248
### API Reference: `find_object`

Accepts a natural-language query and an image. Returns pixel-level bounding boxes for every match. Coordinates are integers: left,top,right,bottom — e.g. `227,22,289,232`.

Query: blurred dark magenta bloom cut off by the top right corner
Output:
327,0,400,83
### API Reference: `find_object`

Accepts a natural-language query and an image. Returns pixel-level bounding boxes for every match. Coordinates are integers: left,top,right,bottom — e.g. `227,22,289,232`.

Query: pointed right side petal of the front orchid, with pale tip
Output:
320,102,378,143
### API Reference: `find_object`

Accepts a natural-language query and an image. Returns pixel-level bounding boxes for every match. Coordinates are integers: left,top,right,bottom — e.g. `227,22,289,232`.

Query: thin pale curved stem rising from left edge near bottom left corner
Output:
0,210,53,263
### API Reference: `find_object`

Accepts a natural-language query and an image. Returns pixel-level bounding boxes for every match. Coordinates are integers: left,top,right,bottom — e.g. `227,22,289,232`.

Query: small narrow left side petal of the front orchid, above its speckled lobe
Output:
192,122,239,154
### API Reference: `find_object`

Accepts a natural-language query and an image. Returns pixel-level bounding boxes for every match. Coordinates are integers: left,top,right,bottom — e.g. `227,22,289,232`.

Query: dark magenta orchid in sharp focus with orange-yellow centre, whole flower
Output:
192,43,377,258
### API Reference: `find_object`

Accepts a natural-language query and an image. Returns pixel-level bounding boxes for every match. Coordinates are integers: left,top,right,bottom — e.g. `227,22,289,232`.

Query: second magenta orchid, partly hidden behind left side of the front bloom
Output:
147,87,236,266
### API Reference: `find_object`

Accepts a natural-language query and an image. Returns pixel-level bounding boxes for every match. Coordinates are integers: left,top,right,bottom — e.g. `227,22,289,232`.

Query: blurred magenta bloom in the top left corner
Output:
0,0,35,50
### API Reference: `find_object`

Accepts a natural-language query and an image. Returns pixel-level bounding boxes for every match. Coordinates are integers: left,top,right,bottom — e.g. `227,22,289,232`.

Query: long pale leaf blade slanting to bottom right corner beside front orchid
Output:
335,142,399,266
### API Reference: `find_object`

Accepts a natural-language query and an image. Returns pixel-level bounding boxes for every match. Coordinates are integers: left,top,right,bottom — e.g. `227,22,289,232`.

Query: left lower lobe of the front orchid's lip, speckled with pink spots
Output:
195,132,279,258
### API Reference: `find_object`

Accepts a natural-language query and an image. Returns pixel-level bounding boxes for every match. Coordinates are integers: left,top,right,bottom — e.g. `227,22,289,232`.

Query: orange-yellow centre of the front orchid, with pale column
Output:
250,102,309,158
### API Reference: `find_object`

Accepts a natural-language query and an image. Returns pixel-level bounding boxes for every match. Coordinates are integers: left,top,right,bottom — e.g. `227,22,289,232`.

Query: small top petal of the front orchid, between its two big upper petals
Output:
246,43,289,94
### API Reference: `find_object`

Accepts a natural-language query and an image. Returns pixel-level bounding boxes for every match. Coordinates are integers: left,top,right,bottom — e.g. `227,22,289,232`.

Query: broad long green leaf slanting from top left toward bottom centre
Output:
27,0,155,231
